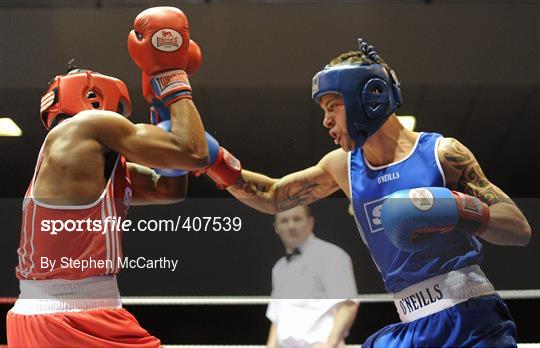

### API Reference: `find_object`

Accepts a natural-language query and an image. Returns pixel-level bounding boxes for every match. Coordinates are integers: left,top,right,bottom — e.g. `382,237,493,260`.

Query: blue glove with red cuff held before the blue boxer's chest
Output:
381,187,490,252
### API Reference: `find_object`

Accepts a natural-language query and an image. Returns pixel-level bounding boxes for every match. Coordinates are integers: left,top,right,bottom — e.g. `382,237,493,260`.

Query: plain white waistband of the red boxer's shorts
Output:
11,276,122,314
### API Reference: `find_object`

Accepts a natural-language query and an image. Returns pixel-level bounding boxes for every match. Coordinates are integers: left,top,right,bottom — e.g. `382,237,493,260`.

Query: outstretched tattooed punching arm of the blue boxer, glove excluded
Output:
227,153,339,214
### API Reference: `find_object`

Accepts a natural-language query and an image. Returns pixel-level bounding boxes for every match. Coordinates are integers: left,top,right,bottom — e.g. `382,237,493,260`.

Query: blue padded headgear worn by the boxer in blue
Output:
311,39,402,147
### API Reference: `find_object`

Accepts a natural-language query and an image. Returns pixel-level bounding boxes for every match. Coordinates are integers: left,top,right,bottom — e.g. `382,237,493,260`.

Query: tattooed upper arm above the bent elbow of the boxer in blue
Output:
438,138,514,206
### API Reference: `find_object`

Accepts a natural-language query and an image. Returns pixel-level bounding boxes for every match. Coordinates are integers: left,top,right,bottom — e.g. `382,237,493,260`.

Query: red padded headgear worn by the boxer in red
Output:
40,70,131,129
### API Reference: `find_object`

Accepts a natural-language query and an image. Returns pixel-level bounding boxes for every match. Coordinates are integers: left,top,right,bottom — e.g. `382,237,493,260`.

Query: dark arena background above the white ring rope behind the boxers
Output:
0,0,540,342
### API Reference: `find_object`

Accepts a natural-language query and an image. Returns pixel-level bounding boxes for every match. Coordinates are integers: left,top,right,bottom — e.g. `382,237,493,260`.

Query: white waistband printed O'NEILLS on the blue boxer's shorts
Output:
394,265,495,322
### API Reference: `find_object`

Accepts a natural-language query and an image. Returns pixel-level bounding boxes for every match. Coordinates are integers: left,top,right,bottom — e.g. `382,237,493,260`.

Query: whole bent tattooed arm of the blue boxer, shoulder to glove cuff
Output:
438,138,531,245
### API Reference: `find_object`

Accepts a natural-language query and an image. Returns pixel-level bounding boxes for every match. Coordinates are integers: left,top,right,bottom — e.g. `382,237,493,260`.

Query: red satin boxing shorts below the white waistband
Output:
7,308,161,348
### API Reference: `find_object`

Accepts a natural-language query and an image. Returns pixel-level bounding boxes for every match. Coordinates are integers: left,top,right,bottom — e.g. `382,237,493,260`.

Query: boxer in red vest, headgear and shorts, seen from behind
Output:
7,7,209,347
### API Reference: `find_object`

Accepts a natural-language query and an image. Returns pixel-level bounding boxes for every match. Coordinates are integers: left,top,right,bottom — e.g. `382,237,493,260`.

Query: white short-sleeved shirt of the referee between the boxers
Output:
266,235,358,348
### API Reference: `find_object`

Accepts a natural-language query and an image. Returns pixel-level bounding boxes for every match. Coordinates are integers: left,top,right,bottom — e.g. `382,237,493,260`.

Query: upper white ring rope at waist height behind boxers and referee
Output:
122,290,540,306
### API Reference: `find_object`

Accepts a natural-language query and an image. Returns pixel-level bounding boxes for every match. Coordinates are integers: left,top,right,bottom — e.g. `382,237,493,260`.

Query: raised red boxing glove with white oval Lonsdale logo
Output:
128,7,191,106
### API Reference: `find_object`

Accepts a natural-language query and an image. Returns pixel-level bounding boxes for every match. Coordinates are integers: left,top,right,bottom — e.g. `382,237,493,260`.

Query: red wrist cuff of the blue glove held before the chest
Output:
452,191,490,236
